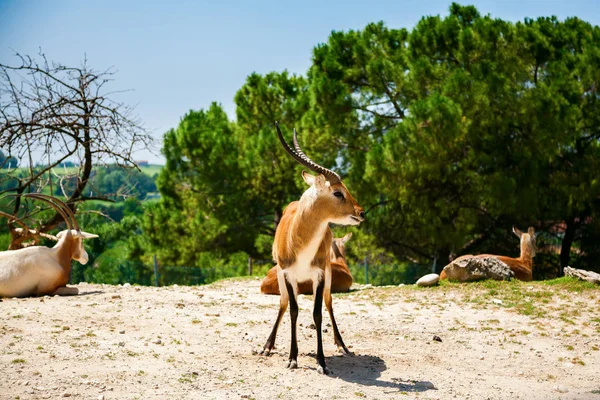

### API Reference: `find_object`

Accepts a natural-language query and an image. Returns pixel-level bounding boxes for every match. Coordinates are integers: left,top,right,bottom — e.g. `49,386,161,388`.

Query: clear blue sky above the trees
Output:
0,0,600,162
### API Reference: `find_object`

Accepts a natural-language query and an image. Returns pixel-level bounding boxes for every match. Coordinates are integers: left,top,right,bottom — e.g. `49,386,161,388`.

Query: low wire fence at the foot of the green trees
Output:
70,259,431,286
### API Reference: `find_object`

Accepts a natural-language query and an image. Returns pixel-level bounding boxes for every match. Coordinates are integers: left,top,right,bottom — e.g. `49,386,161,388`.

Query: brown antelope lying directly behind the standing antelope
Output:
260,231,352,294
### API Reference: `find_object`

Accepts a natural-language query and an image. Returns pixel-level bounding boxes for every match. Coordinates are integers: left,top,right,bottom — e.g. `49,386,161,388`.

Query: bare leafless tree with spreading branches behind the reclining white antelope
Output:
0,53,153,248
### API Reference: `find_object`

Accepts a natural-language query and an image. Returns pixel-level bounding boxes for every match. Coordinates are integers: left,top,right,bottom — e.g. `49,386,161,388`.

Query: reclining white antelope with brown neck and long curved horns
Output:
0,193,98,297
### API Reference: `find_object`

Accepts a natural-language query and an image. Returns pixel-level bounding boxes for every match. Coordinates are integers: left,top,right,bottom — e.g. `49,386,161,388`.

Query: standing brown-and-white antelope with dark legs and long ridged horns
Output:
260,123,365,374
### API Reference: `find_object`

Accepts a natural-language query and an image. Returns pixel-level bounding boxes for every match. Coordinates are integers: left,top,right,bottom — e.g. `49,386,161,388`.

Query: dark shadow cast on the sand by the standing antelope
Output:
308,355,436,392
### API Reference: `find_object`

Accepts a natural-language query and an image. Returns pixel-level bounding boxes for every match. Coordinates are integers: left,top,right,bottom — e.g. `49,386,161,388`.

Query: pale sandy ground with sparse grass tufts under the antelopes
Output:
0,279,600,400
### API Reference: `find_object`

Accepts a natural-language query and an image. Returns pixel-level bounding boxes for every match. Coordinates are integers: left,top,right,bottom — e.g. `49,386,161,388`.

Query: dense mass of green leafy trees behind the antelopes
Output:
2,4,600,284
